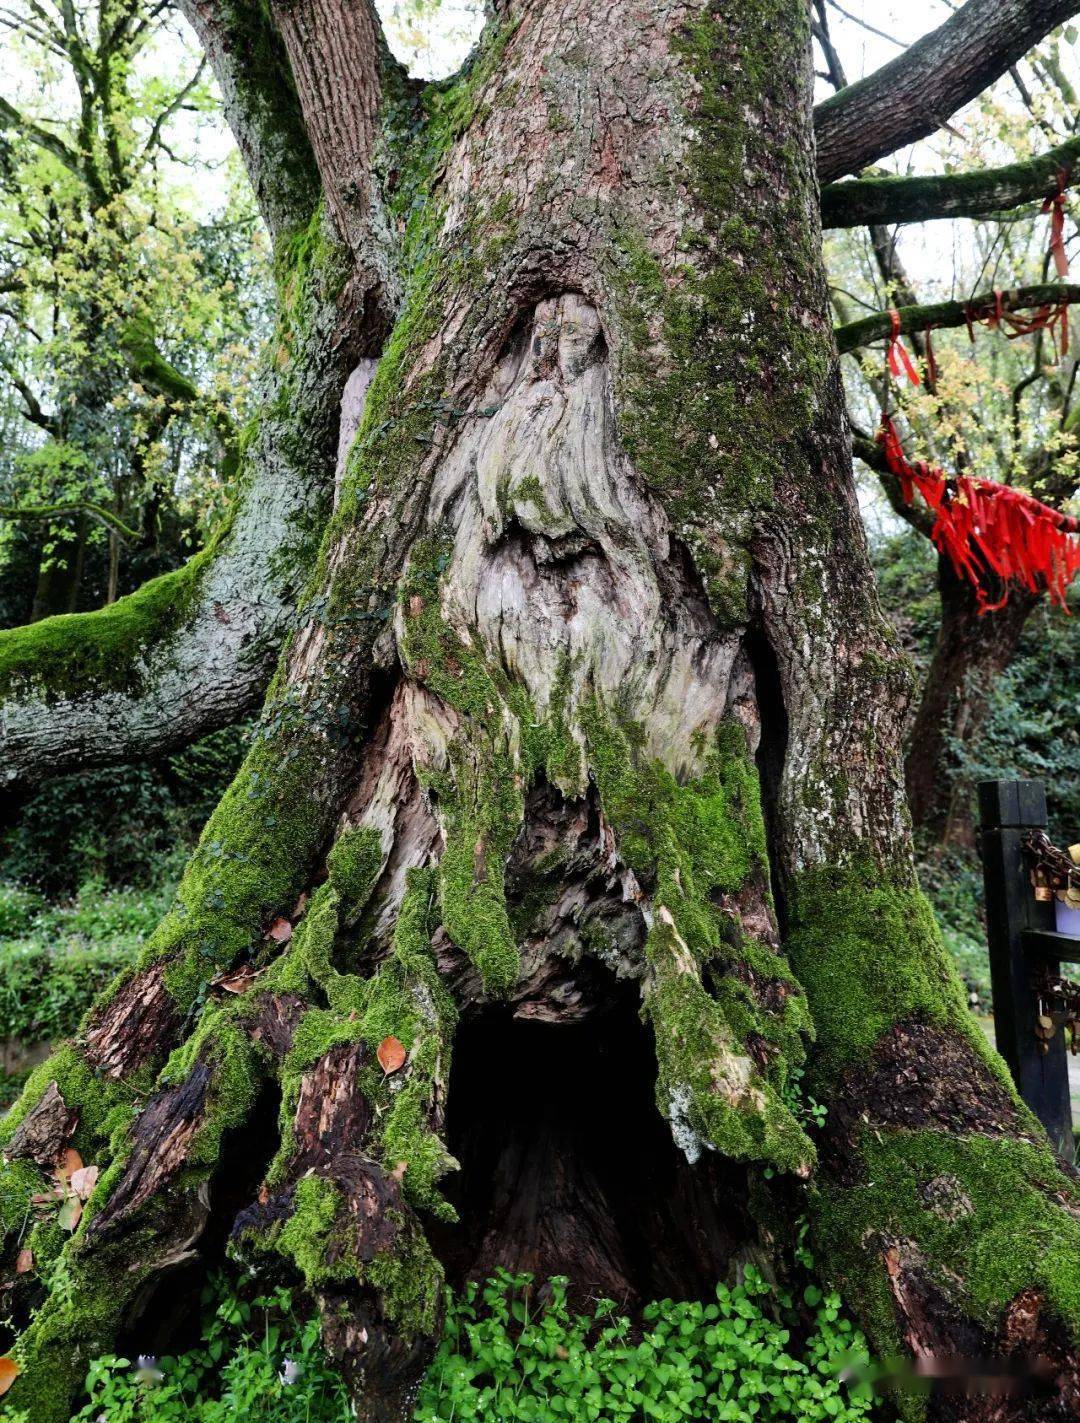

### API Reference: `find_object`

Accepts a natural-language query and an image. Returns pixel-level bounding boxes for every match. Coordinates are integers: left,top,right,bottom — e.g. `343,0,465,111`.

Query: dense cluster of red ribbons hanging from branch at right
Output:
878,416,1080,613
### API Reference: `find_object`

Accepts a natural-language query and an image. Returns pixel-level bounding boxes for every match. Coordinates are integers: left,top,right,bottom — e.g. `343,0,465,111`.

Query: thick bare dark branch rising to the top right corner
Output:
814,0,1080,182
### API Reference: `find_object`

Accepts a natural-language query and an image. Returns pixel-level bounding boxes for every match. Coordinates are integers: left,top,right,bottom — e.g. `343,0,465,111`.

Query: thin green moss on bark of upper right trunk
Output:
612,0,832,625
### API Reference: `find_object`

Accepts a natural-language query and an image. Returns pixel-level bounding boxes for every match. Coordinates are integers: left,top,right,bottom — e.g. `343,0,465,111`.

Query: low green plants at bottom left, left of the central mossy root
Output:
73,1278,350,1423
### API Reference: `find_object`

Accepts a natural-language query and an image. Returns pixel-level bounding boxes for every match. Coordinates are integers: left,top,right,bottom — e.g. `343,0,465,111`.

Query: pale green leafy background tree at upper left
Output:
0,3,263,620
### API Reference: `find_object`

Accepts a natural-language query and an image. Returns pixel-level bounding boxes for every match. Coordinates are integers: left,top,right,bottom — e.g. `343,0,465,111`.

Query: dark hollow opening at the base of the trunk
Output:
434,985,754,1309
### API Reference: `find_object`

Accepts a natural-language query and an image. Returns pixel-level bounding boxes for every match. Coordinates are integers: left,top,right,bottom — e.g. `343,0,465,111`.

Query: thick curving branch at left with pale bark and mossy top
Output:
0,211,357,785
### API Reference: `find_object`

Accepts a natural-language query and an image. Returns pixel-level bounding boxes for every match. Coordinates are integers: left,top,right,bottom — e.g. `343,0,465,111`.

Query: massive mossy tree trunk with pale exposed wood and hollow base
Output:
3,0,1080,1423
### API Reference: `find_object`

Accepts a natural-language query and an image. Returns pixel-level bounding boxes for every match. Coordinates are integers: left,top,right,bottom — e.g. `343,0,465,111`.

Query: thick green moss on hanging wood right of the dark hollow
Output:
582,702,814,1173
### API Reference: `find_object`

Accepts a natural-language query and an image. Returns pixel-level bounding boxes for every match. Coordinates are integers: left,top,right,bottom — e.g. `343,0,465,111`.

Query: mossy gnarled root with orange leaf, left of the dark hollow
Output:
233,865,455,1420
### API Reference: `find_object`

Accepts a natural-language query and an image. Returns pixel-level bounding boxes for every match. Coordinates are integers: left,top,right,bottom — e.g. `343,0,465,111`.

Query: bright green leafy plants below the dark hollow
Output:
415,1268,872,1423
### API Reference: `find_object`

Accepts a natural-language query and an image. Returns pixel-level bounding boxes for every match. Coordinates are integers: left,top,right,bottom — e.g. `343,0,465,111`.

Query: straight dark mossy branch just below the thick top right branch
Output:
821,138,1080,228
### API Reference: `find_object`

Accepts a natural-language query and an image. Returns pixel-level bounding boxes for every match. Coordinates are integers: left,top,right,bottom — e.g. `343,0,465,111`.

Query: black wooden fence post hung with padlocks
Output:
979,781,1073,1161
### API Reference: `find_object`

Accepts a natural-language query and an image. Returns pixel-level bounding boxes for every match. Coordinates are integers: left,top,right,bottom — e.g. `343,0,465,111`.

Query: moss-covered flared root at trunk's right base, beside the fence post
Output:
788,867,1080,1420
